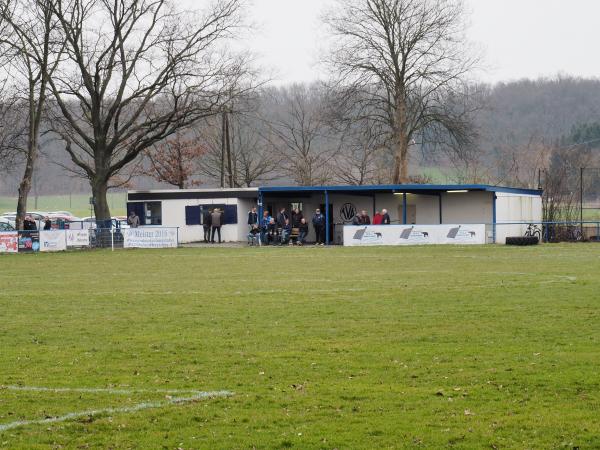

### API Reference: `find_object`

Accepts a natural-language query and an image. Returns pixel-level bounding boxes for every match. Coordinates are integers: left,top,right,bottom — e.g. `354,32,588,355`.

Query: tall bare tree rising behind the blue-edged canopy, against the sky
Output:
325,0,476,183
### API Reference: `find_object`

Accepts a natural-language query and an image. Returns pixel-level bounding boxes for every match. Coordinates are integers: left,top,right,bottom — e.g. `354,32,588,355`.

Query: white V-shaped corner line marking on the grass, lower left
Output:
0,386,233,433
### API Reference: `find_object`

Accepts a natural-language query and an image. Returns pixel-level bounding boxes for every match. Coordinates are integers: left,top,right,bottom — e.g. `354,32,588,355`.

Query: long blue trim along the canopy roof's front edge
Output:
258,184,542,196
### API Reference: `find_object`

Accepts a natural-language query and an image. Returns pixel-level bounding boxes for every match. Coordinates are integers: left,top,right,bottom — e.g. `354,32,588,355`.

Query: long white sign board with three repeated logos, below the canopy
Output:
344,225,485,246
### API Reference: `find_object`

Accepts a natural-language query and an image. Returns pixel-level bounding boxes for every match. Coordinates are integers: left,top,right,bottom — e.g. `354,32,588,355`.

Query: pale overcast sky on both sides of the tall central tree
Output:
243,0,600,83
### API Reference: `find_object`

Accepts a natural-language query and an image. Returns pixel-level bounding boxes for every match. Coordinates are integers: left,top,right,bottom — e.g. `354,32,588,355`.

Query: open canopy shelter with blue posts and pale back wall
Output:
258,184,541,243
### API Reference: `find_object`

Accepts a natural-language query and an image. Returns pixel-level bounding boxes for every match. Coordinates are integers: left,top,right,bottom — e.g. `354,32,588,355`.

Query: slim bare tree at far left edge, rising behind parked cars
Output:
0,0,62,229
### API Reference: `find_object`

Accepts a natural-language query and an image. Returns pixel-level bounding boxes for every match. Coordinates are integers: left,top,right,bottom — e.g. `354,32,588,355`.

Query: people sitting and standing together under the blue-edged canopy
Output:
248,208,391,245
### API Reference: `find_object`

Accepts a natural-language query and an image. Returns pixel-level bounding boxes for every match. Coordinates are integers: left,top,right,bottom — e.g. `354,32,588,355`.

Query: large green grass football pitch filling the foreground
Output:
0,244,600,449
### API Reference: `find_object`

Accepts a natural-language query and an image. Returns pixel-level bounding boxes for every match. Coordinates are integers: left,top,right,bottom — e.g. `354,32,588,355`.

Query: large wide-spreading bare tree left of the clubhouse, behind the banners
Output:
43,0,244,220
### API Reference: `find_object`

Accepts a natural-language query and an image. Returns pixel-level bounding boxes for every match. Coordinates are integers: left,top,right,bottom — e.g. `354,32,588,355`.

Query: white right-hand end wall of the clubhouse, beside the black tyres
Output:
496,192,542,244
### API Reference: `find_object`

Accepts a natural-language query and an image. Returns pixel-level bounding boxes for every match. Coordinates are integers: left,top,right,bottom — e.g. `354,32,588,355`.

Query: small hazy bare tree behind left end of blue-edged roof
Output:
267,85,339,186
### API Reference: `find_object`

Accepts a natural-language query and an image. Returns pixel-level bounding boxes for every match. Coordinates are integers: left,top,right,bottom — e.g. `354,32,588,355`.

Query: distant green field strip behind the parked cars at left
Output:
0,192,127,217
